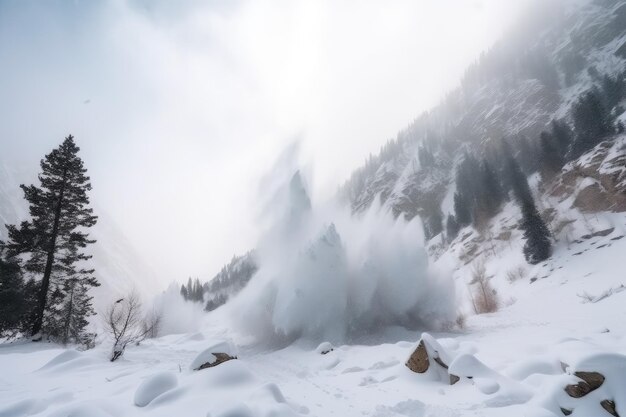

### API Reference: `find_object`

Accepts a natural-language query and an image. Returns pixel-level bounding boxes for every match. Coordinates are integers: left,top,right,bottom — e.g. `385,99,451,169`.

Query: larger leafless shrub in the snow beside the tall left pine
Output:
104,291,160,362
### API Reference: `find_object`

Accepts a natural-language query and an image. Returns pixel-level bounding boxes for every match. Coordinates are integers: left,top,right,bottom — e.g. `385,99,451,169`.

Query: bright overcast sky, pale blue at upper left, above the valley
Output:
0,0,523,280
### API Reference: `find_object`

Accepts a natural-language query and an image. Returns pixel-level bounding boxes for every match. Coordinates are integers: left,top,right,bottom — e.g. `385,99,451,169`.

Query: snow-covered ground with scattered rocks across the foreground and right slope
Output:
0,216,626,417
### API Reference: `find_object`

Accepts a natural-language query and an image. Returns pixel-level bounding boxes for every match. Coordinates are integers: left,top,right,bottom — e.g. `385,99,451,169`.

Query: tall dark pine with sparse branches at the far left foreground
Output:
6,135,99,336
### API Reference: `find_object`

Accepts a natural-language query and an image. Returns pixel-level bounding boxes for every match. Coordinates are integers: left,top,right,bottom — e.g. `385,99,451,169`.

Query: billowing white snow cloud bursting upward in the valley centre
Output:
228,163,454,343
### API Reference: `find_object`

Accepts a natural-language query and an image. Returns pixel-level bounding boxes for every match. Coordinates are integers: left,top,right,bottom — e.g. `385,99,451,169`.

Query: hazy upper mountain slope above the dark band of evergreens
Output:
342,1,626,222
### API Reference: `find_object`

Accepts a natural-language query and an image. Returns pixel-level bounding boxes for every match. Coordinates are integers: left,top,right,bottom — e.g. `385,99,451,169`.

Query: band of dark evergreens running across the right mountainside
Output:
438,71,626,264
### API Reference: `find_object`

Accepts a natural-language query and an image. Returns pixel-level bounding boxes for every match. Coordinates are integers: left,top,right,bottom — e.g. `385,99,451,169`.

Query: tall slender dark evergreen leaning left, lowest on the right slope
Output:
507,148,552,264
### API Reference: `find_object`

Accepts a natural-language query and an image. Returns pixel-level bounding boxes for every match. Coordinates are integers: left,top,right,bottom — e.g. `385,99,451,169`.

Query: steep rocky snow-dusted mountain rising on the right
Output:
197,0,626,316
